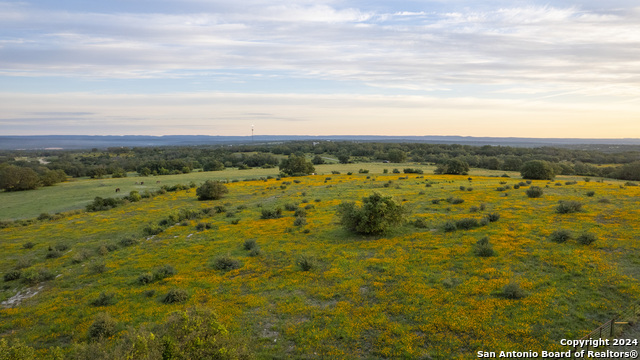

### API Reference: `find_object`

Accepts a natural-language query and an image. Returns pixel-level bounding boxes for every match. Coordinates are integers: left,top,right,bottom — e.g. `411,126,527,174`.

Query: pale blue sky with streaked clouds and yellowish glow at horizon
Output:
0,0,640,138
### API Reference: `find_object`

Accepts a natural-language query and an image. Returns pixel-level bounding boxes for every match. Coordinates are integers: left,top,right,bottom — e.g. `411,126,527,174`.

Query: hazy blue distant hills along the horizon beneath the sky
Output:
0,135,640,150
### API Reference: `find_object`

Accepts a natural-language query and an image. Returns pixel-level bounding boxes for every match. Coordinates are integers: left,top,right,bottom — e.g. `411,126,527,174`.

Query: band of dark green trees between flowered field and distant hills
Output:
0,141,640,191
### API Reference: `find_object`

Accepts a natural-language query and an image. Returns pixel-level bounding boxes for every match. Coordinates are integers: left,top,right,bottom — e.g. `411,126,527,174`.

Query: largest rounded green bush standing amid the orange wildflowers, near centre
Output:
338,192,407,234
